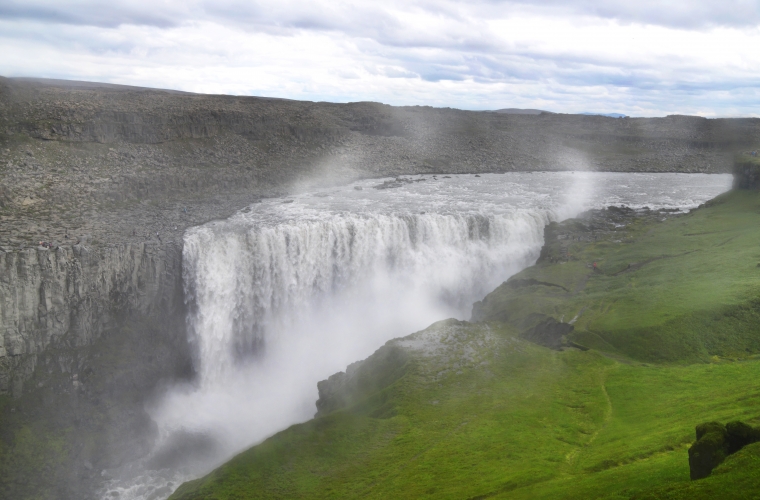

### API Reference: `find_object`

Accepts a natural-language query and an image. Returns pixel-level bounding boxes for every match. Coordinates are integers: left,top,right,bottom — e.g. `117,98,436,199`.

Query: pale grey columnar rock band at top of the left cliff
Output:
0,242,183,396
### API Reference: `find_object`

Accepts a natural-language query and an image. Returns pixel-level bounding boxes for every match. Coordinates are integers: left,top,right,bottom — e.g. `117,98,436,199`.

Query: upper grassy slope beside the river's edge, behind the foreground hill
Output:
480,191,760,362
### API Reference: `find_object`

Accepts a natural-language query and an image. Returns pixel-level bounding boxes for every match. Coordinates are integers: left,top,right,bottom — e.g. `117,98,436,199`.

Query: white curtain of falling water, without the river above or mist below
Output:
184,210,554,383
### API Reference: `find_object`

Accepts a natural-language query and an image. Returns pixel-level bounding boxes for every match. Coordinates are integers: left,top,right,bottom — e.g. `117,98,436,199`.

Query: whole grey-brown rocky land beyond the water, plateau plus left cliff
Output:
0,78,760,498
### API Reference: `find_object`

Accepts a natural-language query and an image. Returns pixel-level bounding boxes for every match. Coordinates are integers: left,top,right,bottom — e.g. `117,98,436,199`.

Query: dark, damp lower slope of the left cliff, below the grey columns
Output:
0,312,192,500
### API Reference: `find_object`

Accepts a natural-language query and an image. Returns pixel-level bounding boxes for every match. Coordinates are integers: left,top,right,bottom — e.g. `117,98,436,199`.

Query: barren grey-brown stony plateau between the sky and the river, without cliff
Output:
0,78,760,251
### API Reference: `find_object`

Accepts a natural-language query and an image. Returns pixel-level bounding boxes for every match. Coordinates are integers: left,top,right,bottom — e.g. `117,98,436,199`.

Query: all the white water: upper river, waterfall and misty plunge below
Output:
101,172,731,498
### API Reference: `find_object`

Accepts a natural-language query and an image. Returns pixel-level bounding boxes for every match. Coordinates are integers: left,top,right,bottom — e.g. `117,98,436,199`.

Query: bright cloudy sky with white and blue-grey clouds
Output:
0,0,760,116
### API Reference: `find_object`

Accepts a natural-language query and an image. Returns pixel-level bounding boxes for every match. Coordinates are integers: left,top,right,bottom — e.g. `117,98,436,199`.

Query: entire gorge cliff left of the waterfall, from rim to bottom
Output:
0,238,192,499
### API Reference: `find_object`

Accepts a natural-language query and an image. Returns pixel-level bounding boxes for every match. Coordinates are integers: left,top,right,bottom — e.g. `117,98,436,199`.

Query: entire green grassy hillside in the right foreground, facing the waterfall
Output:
172,192,760,499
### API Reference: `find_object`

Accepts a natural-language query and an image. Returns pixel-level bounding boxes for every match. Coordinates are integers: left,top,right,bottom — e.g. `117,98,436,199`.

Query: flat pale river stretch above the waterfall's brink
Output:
227,172,732,223
